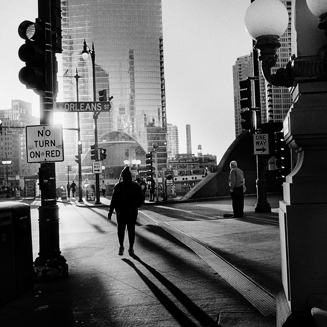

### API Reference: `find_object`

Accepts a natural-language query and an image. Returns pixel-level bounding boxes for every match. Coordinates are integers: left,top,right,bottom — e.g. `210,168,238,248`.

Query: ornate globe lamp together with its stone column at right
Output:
245,0,327,327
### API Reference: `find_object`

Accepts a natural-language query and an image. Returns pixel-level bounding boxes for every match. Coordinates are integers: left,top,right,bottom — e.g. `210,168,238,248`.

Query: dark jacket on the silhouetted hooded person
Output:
109,182,144,213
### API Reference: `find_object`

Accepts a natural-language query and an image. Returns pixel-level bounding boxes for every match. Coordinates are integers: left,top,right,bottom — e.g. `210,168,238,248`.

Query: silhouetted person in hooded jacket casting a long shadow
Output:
108,166,144,255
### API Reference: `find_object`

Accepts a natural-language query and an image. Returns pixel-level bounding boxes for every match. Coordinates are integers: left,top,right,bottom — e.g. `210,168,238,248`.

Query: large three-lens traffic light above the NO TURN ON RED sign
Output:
18,19,46,94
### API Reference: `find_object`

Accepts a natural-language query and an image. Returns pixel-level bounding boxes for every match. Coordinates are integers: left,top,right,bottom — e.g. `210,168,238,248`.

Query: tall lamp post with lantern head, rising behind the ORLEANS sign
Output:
82,40,101,204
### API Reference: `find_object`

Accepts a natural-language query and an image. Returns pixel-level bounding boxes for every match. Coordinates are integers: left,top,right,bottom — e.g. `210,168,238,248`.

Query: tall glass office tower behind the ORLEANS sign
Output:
57,0,167,184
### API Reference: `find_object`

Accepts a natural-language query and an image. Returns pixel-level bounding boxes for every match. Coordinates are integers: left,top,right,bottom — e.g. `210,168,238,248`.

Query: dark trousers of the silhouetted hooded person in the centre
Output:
117,210,137,248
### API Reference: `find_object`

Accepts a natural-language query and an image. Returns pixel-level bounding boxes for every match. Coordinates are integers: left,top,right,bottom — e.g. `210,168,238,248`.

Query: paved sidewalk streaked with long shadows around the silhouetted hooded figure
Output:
0,197,279,327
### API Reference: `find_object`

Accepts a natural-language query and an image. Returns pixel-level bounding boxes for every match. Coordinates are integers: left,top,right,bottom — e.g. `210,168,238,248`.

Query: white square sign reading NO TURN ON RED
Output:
26,125,64,163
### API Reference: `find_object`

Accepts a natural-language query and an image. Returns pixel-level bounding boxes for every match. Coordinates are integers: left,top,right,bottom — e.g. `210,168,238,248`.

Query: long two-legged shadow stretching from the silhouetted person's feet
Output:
122,255,217,327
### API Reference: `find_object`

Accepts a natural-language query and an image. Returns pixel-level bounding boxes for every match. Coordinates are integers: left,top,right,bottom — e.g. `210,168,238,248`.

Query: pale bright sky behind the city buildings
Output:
0,0,252,162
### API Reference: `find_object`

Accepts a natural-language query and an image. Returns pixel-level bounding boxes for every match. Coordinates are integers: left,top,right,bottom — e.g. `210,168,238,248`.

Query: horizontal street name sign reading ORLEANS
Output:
53,101,111,113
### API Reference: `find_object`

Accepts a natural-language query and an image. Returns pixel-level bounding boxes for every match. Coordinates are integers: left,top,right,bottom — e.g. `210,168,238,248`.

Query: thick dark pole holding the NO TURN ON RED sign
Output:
34,0,68,280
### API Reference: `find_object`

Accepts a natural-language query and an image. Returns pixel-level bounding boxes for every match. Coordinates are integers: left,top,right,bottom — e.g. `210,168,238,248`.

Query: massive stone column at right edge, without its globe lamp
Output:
277,0,327,326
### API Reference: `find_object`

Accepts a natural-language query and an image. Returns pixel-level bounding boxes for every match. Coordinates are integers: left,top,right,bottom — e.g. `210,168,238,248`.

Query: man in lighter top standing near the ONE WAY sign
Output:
229,160,245,218
